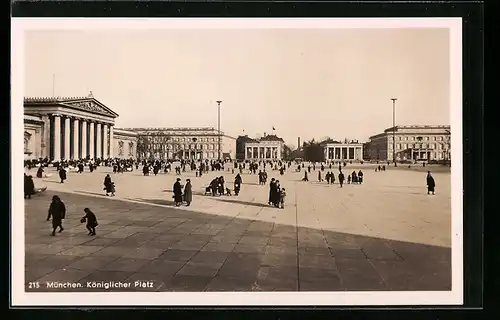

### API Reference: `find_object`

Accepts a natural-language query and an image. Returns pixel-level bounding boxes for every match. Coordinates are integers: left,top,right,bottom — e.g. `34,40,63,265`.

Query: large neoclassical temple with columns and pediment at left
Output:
24,95,118,161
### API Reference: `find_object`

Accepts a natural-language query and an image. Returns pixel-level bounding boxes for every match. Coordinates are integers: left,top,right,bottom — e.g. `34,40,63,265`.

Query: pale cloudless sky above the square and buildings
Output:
24,28,450,146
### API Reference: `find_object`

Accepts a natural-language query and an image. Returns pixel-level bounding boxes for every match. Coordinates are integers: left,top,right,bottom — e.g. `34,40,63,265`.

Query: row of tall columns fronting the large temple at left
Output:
50,114,113,161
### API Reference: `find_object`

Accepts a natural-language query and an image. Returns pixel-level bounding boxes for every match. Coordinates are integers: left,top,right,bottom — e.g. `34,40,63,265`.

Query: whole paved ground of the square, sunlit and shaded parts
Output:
25,167,451,291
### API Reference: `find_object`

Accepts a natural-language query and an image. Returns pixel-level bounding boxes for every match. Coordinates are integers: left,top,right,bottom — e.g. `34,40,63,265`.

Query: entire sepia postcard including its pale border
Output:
11,19,463,305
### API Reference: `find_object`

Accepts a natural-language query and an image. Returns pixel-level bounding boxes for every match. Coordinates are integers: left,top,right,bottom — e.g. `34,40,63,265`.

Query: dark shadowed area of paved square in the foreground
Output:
25,191,451,292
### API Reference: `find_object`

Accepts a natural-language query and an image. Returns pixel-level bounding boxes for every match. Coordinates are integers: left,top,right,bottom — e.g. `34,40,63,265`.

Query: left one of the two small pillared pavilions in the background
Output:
245,135,285,161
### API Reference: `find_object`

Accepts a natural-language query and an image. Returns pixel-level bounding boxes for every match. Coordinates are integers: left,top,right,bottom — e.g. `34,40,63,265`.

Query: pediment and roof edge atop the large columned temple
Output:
24,97,118,118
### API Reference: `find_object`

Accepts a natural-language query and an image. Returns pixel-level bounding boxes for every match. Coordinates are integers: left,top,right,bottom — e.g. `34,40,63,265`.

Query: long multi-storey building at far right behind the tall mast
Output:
365,125,451,161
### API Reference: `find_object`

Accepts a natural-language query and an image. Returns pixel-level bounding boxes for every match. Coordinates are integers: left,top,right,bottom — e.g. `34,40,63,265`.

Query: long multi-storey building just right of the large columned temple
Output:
117,127,236,160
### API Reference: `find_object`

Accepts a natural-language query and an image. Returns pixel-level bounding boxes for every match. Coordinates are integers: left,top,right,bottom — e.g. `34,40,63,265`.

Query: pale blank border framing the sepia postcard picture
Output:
11,18,463,306
